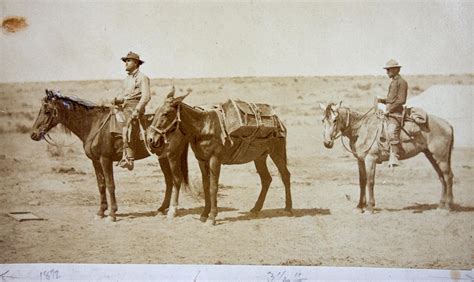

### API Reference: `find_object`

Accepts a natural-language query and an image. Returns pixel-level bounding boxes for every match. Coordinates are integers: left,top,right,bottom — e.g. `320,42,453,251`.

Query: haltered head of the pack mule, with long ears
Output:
146,86,190,150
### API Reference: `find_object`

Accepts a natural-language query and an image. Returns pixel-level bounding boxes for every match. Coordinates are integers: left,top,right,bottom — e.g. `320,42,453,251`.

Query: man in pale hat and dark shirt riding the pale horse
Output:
377,59,408,167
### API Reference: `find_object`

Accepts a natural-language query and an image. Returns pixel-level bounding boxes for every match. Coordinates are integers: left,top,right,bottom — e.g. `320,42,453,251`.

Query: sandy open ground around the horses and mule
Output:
0,75,474,269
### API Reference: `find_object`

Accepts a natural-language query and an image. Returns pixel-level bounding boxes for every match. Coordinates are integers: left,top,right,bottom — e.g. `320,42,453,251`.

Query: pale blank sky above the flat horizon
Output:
0,0,474,82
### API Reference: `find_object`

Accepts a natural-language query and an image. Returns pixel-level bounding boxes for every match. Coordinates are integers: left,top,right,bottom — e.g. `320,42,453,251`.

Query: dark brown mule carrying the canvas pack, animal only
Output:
147,89,292,225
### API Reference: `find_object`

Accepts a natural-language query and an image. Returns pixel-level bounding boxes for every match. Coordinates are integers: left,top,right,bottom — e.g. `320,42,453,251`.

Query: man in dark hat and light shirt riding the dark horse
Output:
113,52,151,170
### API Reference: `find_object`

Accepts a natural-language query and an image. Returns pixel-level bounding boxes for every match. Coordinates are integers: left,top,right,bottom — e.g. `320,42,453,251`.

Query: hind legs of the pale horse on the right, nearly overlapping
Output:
424,151,453,209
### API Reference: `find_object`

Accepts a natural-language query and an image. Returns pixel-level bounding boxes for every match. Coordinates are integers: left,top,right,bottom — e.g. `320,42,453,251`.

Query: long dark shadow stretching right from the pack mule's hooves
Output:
221,209,331,222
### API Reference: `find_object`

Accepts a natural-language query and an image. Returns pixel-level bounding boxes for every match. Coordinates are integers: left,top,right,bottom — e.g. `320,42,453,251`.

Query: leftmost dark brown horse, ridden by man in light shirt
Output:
31,90,188,221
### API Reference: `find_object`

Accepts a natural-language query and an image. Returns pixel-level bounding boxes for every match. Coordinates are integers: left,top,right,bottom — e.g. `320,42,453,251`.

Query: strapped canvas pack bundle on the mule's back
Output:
221,99,278,138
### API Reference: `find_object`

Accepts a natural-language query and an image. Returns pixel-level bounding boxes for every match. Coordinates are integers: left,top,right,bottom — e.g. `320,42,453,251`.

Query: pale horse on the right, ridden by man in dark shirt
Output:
320,102,454,213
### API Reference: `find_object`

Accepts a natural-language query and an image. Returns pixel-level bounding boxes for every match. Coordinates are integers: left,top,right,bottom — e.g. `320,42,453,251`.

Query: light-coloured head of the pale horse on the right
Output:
319,101,342,148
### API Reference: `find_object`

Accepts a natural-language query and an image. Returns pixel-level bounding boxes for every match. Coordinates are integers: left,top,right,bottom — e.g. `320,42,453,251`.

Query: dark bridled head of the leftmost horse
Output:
31,89,65,141
